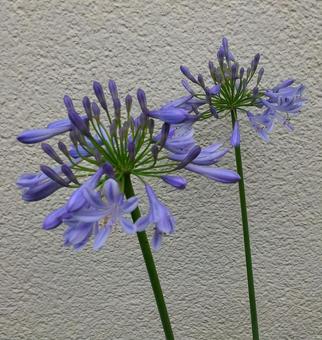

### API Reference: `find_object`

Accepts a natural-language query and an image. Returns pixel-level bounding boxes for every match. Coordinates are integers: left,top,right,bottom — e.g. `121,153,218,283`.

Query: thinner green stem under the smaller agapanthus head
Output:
231,110,259,340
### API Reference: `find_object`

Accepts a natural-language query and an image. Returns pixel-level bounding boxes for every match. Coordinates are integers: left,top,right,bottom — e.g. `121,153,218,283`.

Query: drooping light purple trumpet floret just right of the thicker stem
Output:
135,184,175,251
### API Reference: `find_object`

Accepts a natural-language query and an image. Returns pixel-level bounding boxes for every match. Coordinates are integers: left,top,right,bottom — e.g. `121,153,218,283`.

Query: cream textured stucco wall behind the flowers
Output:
0,0,322,340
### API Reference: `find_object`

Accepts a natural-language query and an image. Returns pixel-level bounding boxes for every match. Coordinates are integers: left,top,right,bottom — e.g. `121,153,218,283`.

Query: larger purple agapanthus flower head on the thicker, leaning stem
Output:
17,80,239,250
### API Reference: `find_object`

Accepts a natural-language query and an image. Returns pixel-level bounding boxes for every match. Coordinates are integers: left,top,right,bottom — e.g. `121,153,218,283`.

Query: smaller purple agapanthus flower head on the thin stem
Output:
180,38,305,142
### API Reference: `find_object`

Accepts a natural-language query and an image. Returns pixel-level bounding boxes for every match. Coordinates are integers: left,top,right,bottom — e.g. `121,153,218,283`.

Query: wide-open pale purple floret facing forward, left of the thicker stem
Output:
64,178,139,250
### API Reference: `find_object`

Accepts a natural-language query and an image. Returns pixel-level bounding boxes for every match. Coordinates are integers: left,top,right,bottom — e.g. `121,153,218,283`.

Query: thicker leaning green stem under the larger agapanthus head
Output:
124,175,174,340
